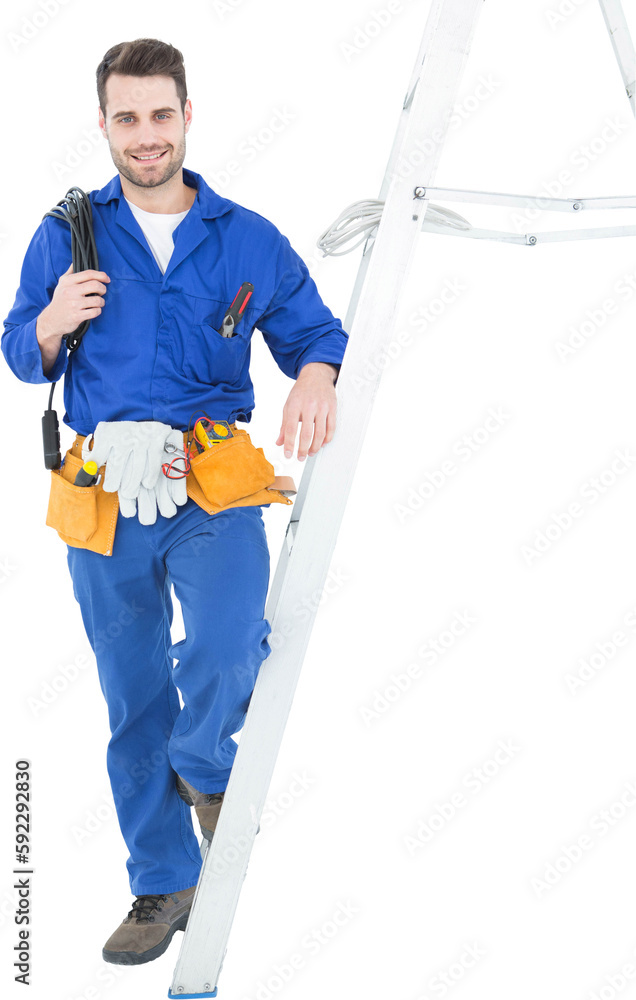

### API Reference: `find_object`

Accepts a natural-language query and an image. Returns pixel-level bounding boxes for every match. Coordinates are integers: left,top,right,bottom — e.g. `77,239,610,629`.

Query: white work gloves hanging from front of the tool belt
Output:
82,420,187,524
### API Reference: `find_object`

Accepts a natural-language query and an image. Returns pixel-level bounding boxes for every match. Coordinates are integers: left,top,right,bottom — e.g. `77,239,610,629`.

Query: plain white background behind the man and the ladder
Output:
0,0,636,1000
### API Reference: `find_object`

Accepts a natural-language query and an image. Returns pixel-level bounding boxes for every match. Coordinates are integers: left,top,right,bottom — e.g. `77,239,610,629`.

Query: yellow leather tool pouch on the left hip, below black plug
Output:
46,446,119,556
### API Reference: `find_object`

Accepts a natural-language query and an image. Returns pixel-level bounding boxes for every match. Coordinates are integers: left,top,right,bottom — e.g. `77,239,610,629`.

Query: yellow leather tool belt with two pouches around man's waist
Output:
46,424,296,556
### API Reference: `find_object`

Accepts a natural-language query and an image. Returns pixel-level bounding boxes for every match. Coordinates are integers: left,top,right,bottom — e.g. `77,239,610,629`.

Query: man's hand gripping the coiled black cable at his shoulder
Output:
35,264,110,375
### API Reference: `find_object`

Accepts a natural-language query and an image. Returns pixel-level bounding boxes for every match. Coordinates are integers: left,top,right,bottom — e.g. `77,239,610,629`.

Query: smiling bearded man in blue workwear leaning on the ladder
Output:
2,39,347,964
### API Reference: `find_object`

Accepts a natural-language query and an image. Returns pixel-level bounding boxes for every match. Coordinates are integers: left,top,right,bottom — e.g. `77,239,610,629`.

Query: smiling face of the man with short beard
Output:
99,73,192,187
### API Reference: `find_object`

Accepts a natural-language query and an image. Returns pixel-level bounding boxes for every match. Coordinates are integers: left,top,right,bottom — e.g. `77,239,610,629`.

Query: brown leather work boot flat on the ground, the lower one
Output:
102,885,196,965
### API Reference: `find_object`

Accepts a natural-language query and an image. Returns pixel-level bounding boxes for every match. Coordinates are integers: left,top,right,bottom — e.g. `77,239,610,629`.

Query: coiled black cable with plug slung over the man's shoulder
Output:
42,187,99,469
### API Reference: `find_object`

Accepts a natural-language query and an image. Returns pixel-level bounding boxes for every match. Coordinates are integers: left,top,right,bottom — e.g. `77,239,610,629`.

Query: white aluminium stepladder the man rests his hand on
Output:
168,0,636,1000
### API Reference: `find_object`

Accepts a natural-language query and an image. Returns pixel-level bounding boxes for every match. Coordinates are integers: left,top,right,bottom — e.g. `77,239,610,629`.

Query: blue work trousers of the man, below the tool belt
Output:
67,498,271,896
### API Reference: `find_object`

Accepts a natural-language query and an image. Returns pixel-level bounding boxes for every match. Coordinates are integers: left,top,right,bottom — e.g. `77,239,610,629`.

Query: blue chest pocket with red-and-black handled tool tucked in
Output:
172,299,251,385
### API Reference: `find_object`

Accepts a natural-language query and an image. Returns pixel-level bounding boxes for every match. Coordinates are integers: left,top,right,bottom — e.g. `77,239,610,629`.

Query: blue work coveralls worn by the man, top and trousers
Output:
2,168,347,895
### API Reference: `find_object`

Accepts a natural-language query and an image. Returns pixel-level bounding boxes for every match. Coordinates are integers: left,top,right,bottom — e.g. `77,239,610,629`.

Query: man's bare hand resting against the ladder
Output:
276,361,338,462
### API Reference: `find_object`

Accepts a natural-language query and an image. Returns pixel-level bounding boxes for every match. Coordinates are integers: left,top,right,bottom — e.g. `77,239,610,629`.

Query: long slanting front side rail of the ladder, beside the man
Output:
169,0,483,998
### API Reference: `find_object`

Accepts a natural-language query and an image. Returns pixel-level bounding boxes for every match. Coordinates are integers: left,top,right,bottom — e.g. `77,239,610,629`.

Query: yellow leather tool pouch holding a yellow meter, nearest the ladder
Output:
188,427,287,508
